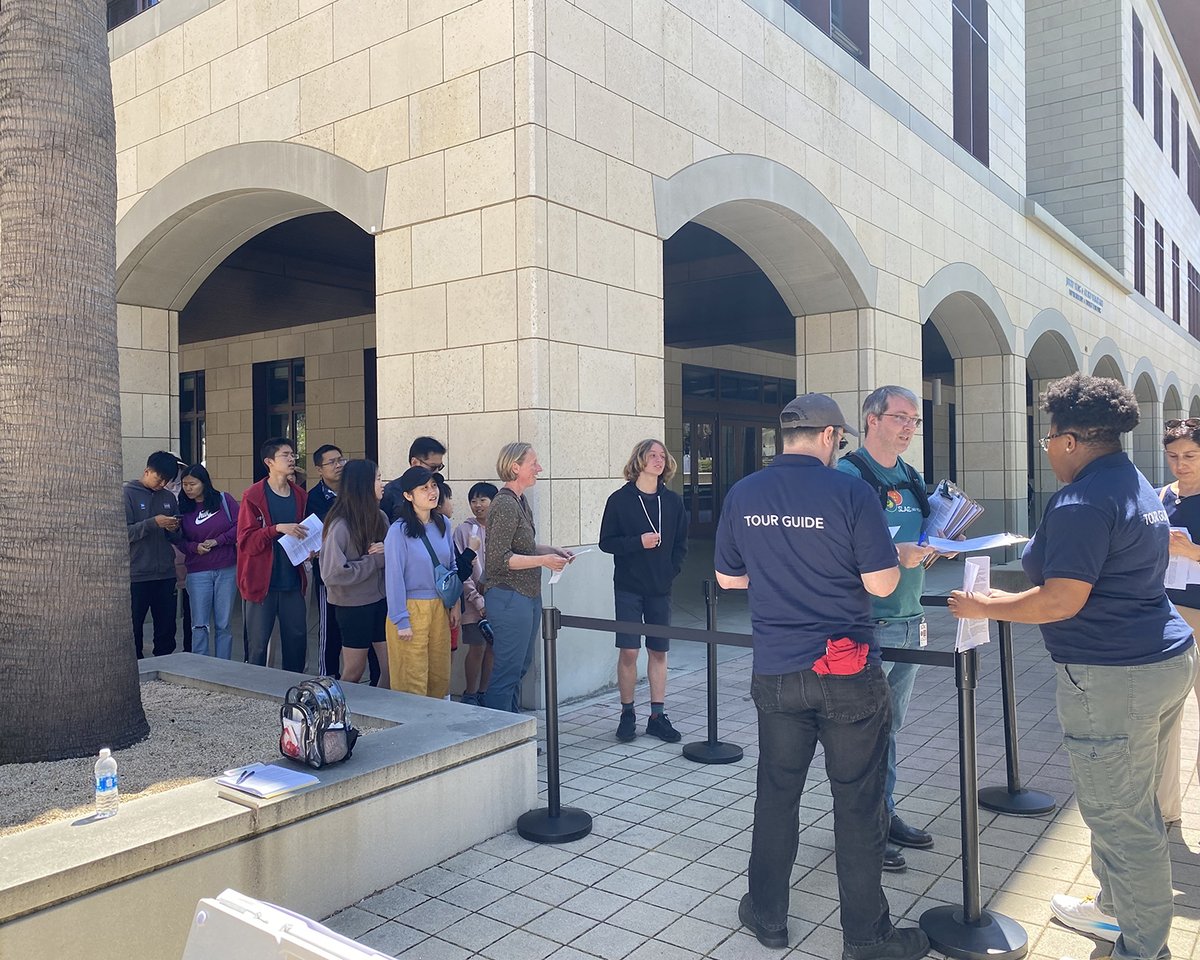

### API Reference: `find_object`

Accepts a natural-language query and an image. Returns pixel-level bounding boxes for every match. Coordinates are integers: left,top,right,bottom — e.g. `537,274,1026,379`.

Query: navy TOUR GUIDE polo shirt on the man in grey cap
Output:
714,454,896,676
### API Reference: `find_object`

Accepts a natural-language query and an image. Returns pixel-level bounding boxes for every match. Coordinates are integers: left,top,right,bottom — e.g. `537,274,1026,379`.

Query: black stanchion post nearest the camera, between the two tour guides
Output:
920,649,1028,960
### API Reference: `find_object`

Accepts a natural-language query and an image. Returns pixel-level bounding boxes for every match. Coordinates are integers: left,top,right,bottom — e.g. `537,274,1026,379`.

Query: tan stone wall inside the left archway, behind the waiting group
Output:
176,317,374,497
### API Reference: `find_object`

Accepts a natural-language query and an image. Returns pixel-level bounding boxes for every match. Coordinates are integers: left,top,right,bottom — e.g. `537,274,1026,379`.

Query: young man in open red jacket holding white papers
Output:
238,437,308,673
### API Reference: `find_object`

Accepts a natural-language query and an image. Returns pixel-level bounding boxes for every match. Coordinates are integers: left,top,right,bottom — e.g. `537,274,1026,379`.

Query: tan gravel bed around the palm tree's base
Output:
0,680,280,836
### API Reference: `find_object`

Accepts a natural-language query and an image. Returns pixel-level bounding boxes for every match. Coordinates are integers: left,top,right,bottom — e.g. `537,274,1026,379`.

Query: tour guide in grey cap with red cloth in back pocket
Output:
715,394,929,960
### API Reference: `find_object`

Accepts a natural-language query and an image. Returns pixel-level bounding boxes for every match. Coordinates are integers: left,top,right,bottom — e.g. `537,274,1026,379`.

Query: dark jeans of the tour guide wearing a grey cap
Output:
750,664,892,946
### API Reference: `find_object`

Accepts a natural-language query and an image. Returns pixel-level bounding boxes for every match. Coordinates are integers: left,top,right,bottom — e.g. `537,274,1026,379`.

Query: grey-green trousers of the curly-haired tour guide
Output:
1055,647,1196,960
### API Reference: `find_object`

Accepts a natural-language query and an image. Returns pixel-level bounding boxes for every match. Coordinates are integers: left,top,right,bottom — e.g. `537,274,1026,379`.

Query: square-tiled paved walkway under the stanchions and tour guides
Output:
328,585,1200,960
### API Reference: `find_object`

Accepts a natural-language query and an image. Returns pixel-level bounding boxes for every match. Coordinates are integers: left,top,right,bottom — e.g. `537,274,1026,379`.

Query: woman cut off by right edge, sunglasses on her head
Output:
1158,418,1200,826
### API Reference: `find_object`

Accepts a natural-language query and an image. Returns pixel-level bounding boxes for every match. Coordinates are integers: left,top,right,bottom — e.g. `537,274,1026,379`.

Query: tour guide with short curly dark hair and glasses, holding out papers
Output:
949,373,1196,960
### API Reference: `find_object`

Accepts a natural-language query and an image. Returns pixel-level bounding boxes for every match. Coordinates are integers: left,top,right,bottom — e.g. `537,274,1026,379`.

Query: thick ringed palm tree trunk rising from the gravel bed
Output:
0,0,149,763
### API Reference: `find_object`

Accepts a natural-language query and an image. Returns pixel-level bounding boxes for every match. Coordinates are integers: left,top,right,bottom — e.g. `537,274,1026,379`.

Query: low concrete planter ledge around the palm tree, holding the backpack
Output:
0,654,536,959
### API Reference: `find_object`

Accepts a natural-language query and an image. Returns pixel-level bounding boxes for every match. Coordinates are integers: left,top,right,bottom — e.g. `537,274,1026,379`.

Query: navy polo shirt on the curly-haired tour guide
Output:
1021,452,1193,666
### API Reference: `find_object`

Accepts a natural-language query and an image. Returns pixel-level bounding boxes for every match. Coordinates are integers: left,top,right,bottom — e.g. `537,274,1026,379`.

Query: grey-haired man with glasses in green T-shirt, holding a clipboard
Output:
838,384,934,871
